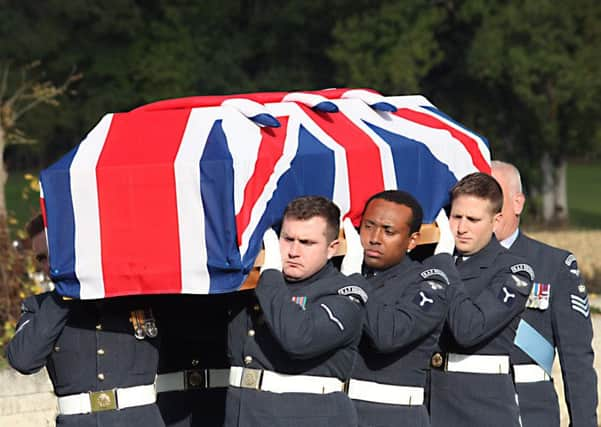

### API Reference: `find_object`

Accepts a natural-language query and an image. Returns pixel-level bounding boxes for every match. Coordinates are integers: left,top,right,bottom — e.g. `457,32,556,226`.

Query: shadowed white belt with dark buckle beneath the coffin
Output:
156,369,230,393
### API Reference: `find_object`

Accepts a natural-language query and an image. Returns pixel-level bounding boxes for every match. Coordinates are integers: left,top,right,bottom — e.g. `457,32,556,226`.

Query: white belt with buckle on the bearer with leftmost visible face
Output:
230,366,344,394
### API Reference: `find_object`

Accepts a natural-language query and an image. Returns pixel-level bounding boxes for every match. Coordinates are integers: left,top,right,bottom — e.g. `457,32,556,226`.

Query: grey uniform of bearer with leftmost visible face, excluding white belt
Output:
225,263,365,427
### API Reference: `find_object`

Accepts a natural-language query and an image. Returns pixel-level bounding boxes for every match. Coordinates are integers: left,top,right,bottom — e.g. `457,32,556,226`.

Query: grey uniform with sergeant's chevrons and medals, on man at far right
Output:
509,232,597,427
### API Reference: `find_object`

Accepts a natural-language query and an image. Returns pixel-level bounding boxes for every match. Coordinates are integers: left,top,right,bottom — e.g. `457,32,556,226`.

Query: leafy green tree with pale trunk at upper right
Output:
467,0,601,226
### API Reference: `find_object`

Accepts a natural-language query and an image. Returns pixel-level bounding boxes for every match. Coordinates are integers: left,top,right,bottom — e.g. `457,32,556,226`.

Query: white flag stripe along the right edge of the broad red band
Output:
173,107,223,294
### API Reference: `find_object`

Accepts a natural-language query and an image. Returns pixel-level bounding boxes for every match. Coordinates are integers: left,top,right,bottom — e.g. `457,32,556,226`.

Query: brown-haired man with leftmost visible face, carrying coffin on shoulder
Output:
225,196,367,427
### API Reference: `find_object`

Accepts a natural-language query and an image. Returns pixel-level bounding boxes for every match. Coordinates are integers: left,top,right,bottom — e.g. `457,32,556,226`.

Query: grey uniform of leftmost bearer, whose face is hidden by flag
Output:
6,292,164,427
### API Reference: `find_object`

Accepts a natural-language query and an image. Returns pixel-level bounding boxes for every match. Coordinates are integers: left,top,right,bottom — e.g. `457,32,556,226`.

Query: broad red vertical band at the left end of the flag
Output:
96,110,190,297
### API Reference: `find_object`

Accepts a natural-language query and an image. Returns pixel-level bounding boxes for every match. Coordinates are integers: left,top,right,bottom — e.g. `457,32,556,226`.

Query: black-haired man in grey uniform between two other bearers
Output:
343,190,448,427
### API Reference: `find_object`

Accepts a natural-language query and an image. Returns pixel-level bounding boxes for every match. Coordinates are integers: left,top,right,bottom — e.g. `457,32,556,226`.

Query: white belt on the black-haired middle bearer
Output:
348,379,424,406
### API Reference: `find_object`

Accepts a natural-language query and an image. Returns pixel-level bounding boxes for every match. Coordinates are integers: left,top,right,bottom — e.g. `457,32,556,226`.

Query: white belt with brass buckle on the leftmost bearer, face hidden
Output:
58,384,156,415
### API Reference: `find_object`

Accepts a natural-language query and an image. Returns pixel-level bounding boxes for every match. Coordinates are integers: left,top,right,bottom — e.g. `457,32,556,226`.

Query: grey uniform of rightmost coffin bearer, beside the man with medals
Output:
430,237,532,427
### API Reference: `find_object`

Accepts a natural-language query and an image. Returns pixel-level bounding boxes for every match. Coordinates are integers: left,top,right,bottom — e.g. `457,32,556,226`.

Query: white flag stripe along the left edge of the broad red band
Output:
69,114,113,299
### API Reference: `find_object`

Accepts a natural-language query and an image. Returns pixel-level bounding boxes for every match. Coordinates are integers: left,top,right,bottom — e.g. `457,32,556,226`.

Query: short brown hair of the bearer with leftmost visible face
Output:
284,196,340,243
